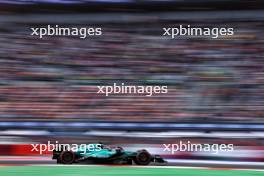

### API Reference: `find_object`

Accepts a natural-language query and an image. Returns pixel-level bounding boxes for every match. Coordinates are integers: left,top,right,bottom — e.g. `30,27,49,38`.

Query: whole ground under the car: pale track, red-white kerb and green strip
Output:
0,156,264,176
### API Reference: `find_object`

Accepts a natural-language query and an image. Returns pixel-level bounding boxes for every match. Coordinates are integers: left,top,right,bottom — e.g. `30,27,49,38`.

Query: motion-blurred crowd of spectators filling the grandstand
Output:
0,20,264,123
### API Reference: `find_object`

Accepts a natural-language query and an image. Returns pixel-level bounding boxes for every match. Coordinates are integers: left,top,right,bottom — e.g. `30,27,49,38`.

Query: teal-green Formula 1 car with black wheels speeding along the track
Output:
52,144,166,165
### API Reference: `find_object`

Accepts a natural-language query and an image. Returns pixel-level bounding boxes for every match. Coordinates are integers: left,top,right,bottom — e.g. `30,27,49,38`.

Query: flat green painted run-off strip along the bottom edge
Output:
0,165,264,176
